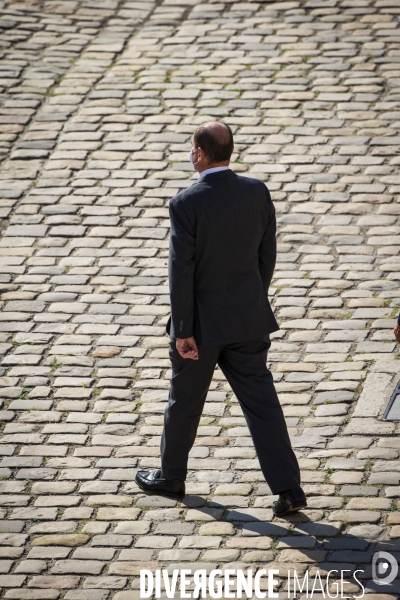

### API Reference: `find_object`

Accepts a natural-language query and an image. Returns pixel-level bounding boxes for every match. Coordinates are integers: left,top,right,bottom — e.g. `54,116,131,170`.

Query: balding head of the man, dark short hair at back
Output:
193,121,233,164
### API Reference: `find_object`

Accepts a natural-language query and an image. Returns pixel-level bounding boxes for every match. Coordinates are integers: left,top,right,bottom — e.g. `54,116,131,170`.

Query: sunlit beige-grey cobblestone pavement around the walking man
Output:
0,0,400,600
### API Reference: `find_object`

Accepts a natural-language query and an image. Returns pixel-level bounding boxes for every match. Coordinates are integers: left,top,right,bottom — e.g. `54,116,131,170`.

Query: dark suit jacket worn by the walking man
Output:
167,169,279,346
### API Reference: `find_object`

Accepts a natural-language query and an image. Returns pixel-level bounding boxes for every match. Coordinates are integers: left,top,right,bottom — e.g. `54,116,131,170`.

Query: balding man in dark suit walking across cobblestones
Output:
136,122,307,516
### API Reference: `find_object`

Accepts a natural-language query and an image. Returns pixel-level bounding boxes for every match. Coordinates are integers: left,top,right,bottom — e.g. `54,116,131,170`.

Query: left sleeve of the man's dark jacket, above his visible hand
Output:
168,200,195,338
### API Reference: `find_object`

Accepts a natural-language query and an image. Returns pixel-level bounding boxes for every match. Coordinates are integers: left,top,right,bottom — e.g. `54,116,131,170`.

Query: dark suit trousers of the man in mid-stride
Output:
161,336,300,494
